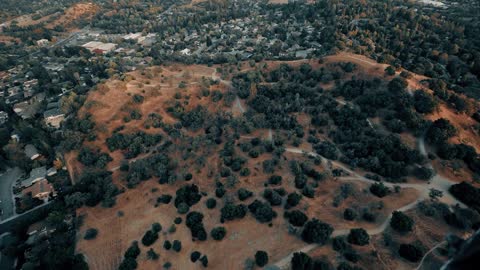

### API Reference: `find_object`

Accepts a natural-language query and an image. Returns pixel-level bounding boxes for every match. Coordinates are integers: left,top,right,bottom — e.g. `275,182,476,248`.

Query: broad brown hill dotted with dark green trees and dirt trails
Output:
71,53,478,269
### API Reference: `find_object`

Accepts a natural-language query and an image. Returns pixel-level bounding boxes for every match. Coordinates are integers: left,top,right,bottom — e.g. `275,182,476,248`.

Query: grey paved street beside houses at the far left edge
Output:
0,167,22,220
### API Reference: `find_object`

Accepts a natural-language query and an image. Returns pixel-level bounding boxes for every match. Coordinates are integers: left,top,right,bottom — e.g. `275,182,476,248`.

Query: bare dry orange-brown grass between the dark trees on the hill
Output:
73,53,478,270
